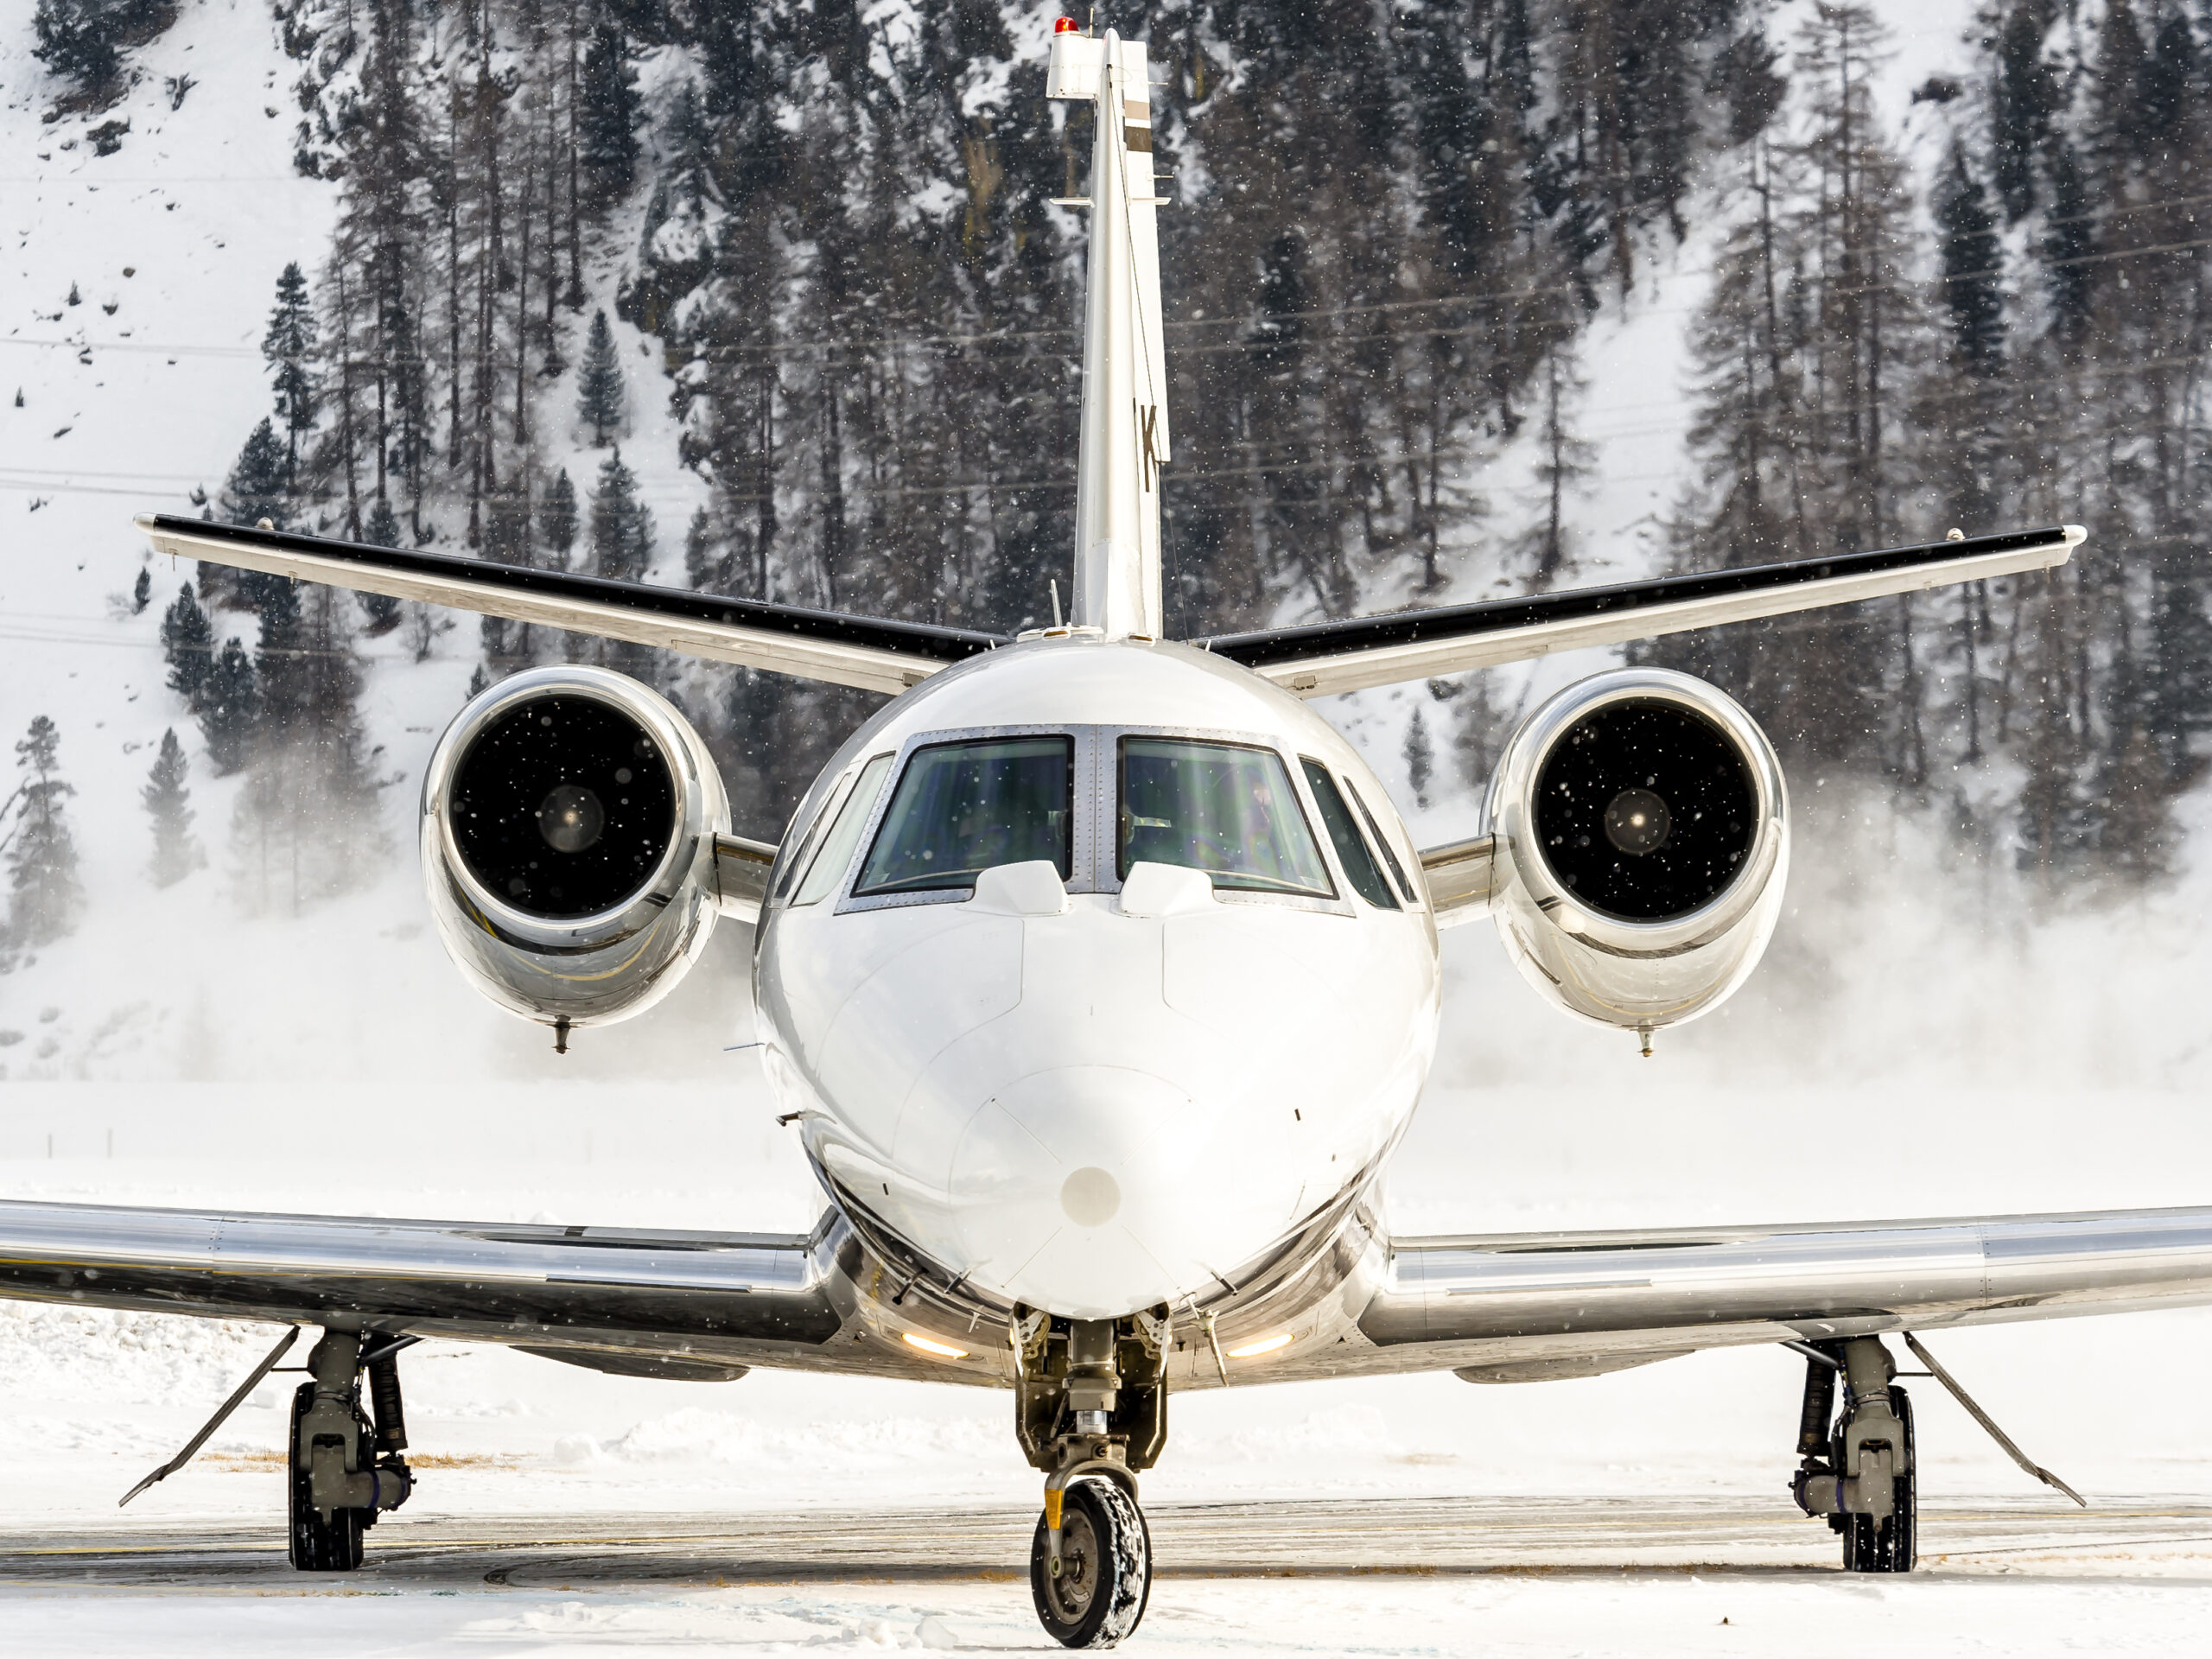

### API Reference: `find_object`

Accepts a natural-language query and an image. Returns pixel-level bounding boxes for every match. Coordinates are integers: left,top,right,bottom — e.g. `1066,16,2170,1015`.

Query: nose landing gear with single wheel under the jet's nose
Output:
1013,1307,1168,1648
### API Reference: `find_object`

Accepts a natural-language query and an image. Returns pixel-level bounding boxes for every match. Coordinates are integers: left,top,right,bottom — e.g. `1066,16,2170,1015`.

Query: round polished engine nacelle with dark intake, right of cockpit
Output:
1489,668,1789,1051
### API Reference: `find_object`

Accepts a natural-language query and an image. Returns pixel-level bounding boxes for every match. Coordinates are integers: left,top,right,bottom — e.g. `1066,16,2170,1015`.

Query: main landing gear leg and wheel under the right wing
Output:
1789,1336,1920,1573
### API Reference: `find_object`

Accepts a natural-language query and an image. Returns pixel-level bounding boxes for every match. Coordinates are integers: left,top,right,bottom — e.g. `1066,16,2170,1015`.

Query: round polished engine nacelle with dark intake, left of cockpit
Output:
423,666,730,1046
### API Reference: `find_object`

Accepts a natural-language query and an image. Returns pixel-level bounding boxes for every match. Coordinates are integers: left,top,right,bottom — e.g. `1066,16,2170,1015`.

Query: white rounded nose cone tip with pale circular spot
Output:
951,1066,1296,1319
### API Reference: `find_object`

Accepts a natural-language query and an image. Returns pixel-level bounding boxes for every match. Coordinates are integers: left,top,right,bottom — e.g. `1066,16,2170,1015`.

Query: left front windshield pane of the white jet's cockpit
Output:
852,736,1075,898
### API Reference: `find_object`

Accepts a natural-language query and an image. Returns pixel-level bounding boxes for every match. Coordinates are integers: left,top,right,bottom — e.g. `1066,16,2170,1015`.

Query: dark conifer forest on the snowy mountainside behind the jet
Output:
11,0,2212,925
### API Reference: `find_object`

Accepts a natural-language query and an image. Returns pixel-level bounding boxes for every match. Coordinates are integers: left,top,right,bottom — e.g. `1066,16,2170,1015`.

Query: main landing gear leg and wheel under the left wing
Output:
289,1332,414,1573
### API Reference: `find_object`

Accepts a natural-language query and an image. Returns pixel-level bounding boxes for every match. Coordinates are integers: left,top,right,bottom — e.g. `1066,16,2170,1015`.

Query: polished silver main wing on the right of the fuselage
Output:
1327,1208,2212,1382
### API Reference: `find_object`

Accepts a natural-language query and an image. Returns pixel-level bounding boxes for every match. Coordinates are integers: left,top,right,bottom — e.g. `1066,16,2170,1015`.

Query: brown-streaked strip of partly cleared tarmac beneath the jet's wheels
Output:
0,1496,2212,1592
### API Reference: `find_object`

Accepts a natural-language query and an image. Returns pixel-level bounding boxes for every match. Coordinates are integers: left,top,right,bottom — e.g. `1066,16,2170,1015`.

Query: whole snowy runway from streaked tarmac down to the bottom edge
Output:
0,1497,2212,1655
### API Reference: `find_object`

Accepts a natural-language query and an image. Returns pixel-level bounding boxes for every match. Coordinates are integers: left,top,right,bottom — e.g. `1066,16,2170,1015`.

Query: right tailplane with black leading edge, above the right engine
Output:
1194,524,2088,696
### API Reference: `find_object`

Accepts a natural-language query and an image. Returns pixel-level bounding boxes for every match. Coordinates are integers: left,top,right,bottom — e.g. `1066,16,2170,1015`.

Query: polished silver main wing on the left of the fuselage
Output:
0,1204,984,1380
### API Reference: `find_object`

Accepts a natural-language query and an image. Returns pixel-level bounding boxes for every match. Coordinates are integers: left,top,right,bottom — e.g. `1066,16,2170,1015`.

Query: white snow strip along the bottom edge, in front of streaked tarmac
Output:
13,1575,2212,1659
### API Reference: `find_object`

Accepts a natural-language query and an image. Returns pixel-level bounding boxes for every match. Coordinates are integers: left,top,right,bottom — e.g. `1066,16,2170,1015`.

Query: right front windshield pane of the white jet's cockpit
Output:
1117,736,1336,898
